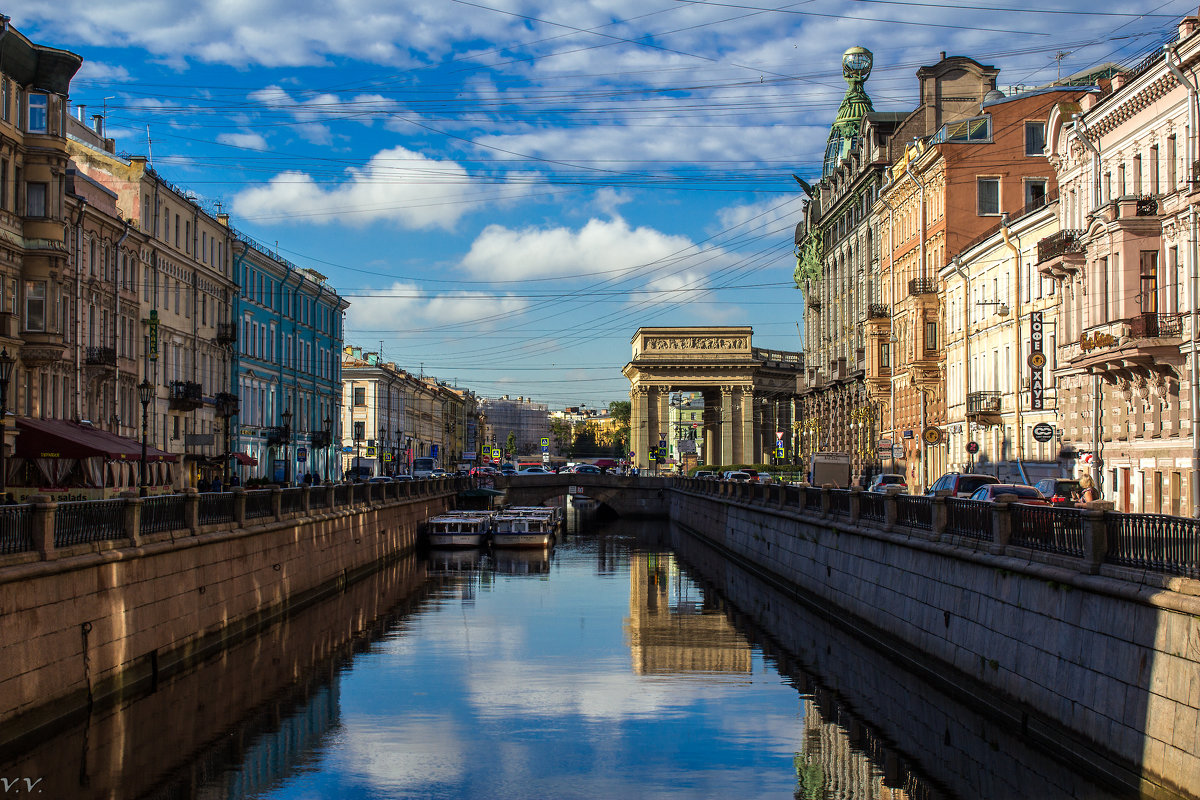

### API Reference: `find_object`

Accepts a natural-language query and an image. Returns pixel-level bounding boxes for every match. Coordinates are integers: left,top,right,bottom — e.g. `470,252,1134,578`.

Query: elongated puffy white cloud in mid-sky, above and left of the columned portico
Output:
461,217,695,281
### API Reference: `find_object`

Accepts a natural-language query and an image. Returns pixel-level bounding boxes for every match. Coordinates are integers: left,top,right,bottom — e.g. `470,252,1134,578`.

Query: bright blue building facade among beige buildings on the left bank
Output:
232,233,349,483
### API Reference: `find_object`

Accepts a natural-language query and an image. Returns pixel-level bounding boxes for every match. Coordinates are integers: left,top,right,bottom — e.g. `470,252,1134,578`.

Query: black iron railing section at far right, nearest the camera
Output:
1104,511,1200,578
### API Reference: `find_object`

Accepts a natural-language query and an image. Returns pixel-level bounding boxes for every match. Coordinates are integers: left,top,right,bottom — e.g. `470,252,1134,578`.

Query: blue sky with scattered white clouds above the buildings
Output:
4,0,1196,408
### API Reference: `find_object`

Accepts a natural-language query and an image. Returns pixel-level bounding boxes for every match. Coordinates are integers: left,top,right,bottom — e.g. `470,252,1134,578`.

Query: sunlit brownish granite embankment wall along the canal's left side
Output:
0,483,458,746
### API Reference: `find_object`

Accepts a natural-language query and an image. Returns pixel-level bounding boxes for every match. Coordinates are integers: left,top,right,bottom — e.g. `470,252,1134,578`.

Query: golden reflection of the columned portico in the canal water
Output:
625,553,752,675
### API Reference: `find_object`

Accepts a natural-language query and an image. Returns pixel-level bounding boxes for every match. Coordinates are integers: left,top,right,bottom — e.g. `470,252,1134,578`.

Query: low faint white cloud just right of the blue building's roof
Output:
346,282,529,332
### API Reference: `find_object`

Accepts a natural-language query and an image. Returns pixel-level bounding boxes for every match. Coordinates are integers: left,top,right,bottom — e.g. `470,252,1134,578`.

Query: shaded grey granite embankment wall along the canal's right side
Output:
671,482,1200,796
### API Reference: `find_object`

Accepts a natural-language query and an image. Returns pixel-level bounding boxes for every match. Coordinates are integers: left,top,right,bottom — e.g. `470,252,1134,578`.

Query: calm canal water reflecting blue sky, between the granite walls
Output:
0,510,1126,800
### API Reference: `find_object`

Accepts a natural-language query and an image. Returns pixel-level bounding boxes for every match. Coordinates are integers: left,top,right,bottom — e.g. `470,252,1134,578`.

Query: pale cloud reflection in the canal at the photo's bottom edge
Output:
340,716,468,798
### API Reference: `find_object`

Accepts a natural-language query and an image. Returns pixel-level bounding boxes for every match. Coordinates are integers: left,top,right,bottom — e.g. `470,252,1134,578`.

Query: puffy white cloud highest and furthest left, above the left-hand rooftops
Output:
234,148,484,229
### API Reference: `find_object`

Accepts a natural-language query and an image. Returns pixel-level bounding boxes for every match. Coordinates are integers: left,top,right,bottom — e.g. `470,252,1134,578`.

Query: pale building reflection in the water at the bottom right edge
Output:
796,697,929,800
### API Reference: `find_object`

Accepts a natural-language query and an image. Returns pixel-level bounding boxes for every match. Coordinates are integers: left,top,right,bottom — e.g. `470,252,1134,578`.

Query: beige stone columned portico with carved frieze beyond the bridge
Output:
624,326,804,469
